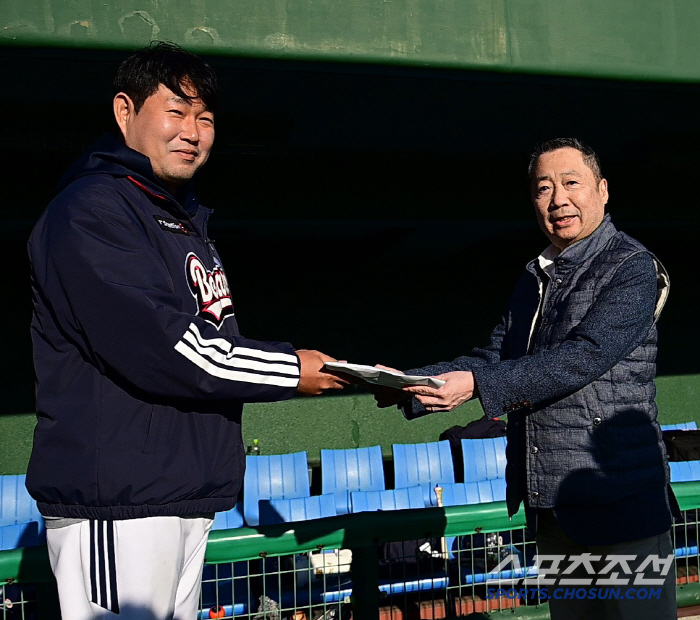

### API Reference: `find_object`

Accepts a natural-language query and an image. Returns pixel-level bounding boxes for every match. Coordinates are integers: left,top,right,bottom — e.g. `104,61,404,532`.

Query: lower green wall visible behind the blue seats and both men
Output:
5,375,700,474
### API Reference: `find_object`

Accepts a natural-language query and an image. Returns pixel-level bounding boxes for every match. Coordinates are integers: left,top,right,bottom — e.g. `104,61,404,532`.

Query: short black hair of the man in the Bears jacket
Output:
114,41,219,113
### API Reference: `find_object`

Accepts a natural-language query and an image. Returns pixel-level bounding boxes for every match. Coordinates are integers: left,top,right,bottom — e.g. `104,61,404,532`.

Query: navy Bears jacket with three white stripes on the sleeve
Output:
27,136,299,519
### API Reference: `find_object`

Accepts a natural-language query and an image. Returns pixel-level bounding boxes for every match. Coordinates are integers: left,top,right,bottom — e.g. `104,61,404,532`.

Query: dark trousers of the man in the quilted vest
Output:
537,510,677,620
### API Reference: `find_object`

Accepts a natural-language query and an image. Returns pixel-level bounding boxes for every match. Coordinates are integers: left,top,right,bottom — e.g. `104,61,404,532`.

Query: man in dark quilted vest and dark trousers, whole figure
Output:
377,139,676,620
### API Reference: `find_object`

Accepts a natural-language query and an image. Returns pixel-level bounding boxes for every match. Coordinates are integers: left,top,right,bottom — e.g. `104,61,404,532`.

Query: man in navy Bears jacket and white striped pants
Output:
27,43,345,620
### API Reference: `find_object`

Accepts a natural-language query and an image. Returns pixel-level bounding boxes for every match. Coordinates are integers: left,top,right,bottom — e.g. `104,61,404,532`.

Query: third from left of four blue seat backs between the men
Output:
392,440,455,506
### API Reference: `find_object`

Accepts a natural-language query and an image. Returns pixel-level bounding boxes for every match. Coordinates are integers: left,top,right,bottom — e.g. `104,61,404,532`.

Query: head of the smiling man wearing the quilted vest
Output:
531,147,608,250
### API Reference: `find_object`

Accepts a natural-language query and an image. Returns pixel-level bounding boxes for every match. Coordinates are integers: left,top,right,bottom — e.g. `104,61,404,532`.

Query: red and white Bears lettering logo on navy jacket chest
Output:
185,252,233,329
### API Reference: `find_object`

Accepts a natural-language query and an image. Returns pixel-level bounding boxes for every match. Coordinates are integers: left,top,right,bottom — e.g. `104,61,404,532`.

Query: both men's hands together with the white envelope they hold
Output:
297,349,476,413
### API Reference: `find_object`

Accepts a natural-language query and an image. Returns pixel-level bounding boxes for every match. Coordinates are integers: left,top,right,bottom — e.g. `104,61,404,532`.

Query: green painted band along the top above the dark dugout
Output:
0,0,700,81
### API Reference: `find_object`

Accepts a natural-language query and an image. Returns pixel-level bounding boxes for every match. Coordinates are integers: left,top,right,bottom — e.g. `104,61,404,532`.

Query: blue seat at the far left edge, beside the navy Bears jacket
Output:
0,474,46,551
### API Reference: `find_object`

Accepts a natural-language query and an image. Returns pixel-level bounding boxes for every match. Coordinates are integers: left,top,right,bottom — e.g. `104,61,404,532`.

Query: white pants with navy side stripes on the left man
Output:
46,517,212,620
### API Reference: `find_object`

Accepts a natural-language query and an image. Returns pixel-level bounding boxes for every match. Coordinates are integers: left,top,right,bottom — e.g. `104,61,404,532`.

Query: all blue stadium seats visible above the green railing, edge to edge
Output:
0,422,700,550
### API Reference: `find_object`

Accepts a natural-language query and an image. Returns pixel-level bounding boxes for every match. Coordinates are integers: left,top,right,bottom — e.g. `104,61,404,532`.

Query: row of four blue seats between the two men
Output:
238,437,506,527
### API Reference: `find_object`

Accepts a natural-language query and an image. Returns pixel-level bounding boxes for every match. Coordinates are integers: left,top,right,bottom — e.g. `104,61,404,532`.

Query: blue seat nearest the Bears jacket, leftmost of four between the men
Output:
243,452,311,527
